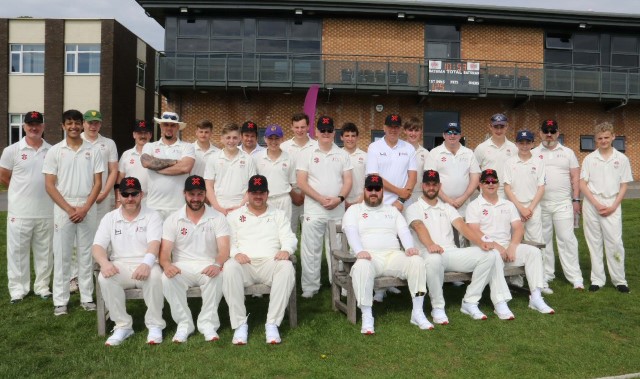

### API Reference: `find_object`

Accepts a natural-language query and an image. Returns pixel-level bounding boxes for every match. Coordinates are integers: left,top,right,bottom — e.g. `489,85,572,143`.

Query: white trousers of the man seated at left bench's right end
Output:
222,257,296,329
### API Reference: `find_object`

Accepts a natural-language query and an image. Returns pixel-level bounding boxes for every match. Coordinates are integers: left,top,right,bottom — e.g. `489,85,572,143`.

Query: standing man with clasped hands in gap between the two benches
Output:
296,116,353,298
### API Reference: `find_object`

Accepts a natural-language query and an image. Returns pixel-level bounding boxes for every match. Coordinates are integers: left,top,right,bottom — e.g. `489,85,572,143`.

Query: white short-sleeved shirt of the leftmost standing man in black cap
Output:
0,137,53,218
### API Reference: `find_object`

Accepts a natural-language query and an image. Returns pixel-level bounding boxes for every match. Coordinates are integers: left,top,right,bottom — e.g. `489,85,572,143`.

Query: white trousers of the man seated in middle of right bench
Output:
420,246,496,308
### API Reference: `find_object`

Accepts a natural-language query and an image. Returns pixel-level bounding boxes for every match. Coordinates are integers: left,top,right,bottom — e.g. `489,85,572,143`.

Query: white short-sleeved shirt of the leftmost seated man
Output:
93,206,162,263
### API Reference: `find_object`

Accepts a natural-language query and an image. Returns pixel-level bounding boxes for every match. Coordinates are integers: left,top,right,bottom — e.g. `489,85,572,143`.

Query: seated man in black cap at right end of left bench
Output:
224,175,298,345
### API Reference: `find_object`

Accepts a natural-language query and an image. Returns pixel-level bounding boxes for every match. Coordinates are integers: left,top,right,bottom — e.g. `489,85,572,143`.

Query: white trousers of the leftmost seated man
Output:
98,261,166,329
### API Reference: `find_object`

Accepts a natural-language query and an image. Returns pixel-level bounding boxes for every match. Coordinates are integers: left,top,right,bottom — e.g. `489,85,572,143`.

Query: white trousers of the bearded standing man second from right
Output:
540,199,583,284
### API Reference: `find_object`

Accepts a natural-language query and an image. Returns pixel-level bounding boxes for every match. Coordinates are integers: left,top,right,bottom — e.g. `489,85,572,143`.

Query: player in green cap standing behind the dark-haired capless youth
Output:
81,110,118,222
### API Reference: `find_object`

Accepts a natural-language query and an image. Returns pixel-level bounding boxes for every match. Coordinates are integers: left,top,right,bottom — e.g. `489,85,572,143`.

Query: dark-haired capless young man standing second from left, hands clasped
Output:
42,109,104,316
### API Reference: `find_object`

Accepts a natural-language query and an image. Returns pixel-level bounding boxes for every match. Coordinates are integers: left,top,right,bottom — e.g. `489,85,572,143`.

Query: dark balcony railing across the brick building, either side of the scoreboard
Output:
158,52,640,99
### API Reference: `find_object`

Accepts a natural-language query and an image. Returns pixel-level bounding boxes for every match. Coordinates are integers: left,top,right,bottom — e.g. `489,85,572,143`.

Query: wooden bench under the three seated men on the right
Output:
328,221,544,324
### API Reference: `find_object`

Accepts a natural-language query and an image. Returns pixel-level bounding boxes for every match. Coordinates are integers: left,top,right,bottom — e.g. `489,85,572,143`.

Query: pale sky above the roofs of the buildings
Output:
0,0,640,51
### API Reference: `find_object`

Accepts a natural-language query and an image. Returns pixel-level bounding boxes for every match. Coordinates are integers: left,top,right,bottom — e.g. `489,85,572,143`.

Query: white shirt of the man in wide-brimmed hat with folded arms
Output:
142,139,195,210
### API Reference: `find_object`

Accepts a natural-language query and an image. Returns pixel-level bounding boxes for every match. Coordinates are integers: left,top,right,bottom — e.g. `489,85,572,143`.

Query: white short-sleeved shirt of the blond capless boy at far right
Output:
580,148,633,198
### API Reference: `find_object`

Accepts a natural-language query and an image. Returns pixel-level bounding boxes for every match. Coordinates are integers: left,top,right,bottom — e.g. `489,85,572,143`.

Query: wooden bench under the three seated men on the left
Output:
94,255,298,336
